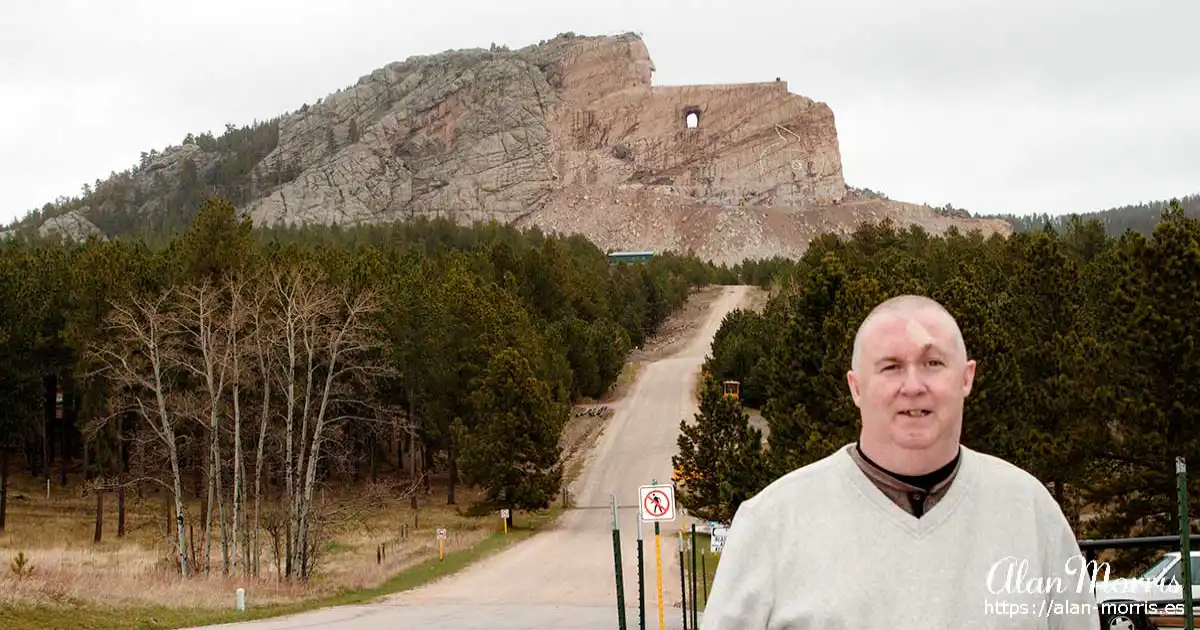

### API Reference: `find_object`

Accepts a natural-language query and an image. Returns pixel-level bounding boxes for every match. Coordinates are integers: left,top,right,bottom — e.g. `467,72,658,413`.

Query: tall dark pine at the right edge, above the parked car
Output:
1091,204,1200,549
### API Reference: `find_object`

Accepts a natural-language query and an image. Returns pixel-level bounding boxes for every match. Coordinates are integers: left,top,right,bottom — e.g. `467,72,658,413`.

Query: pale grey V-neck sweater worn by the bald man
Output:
701,444,1099,630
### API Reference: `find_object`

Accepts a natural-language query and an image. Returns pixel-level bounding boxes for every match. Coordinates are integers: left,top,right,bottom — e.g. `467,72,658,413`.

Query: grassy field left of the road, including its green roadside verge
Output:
0,460,562,630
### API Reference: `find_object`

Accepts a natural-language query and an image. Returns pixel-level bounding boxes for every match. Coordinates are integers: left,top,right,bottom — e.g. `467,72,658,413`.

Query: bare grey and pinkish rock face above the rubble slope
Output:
238,35,845,230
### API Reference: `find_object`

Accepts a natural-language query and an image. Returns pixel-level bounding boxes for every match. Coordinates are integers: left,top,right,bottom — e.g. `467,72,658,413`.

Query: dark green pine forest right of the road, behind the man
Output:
674,200,1200,566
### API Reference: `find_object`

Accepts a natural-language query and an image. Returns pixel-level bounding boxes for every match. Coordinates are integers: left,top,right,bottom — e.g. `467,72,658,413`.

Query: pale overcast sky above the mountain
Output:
0,0,1200,223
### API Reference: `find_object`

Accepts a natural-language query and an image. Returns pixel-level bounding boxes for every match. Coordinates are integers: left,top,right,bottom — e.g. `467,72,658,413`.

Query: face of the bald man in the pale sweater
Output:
847,308,974,452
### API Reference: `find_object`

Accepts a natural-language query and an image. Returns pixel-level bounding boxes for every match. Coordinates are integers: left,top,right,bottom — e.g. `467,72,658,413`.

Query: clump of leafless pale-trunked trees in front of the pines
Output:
87,266,408,580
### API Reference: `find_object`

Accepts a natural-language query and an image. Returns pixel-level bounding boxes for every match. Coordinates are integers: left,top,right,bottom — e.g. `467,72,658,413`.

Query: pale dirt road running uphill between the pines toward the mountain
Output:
183,287,749,630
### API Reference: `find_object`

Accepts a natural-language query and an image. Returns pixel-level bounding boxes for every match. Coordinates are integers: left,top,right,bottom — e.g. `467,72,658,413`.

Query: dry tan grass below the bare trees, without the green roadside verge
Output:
0,465,546,608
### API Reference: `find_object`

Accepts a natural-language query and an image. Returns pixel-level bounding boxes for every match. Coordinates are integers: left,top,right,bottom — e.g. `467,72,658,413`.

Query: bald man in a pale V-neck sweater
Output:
701,295,1099,630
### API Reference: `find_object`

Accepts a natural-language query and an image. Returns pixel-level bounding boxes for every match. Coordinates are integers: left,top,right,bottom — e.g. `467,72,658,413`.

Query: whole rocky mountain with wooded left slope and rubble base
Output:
2,34,1012,262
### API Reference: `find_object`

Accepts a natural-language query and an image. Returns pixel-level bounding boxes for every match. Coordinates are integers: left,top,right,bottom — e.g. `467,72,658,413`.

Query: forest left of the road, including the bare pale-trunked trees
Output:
0,197,770,580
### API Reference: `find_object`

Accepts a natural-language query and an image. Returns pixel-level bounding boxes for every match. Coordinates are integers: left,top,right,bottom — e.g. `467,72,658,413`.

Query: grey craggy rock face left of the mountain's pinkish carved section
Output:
246,43,558,224
